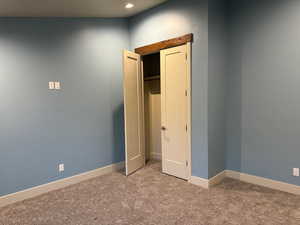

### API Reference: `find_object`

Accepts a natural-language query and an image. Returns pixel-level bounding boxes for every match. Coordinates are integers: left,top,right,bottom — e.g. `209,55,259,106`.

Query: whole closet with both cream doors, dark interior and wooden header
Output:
123,34,193,180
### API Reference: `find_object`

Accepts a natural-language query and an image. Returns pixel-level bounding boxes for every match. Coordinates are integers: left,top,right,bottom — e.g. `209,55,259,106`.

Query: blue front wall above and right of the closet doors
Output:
129,0,208,178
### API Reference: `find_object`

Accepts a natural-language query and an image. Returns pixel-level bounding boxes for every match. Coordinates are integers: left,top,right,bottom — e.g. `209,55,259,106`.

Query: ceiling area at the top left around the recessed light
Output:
0,0,167,18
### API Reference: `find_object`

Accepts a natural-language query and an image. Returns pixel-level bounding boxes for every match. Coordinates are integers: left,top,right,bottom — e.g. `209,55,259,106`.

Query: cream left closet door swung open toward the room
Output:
123,51,145,175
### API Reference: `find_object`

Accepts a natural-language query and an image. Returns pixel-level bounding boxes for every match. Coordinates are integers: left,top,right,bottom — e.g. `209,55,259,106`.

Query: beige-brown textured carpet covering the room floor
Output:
0,162,300,225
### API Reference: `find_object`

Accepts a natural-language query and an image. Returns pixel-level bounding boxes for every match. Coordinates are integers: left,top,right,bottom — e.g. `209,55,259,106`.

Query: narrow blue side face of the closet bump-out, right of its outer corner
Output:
207,0,228,178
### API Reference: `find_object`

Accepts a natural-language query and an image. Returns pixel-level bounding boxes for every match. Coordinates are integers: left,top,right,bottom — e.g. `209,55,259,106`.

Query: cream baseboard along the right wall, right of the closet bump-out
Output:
226,170,300,195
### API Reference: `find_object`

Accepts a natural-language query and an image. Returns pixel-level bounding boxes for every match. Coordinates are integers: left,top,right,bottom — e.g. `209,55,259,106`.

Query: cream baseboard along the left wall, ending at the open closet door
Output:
0,162,125,208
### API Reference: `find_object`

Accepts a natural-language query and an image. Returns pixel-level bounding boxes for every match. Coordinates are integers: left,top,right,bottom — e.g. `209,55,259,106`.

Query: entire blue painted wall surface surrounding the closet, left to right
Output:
0,0,300,196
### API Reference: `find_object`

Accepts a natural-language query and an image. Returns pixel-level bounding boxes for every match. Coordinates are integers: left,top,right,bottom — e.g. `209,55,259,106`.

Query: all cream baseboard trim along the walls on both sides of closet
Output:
0,162,300,208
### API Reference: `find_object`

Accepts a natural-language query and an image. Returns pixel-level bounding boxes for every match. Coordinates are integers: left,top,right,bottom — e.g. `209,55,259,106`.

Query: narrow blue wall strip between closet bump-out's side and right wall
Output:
226,1,243,171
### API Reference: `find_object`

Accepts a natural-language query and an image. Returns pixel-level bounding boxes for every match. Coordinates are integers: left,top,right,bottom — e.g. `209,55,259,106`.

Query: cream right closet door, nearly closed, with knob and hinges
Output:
161,45,189,179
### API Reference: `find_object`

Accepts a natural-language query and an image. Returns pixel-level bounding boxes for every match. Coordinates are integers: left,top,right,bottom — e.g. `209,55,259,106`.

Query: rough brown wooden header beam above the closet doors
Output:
135,34,193,56
